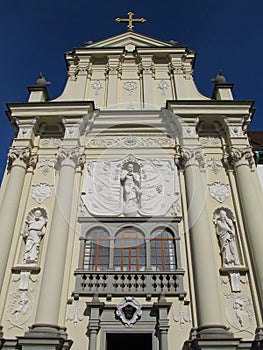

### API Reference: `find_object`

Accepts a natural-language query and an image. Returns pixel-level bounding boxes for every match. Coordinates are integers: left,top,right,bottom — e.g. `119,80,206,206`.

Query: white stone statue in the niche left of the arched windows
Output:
23,208,47,263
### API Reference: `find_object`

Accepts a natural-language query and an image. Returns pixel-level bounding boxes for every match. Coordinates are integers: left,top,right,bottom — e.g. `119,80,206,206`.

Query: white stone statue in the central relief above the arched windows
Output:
120,163,142,216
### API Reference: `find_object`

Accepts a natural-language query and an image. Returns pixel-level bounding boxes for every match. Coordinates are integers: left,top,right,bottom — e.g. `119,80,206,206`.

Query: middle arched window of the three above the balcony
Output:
113,227,146,271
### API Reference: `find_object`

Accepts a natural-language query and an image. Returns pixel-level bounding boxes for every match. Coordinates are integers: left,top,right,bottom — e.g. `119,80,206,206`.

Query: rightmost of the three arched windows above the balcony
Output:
151,229,176,271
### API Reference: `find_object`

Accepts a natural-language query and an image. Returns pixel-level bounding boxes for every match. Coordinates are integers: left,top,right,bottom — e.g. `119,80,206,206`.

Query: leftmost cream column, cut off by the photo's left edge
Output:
0,148,31,289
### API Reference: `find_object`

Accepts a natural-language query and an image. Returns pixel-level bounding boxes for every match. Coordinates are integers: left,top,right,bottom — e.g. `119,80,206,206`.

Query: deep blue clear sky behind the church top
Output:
0,0,263,178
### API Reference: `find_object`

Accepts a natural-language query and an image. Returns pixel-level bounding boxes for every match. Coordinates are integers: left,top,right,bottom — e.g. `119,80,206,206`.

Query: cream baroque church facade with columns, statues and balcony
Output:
0,31,263,350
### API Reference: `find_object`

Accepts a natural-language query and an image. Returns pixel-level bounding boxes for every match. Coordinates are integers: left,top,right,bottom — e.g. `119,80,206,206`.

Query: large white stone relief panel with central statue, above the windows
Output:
81,156,179,216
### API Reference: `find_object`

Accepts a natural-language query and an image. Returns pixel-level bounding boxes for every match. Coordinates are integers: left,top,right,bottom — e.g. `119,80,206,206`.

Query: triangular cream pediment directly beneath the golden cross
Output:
86,32,173,48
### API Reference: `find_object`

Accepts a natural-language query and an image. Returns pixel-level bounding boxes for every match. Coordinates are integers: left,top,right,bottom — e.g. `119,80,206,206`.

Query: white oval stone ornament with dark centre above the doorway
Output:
116,297,142,327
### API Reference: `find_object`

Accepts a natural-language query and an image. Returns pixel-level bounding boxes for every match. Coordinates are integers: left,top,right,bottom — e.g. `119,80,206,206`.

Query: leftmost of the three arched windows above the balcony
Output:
83,227,110,271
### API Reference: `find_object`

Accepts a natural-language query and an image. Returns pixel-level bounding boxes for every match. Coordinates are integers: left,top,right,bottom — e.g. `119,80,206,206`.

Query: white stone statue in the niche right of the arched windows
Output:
214,209,240,267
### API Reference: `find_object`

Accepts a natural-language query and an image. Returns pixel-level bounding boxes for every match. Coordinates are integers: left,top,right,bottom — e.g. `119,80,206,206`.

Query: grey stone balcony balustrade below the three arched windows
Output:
74,269,186,297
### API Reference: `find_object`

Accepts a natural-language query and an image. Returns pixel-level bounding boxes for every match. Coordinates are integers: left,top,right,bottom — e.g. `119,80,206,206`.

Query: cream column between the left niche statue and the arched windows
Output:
36,147,79,326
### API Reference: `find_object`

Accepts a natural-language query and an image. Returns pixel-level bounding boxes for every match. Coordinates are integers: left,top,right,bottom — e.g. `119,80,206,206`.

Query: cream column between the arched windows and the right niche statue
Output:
181,147,230,337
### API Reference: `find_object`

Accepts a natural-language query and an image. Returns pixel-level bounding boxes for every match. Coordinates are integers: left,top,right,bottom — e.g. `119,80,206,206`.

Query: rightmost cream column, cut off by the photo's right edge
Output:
228,147,263,324
